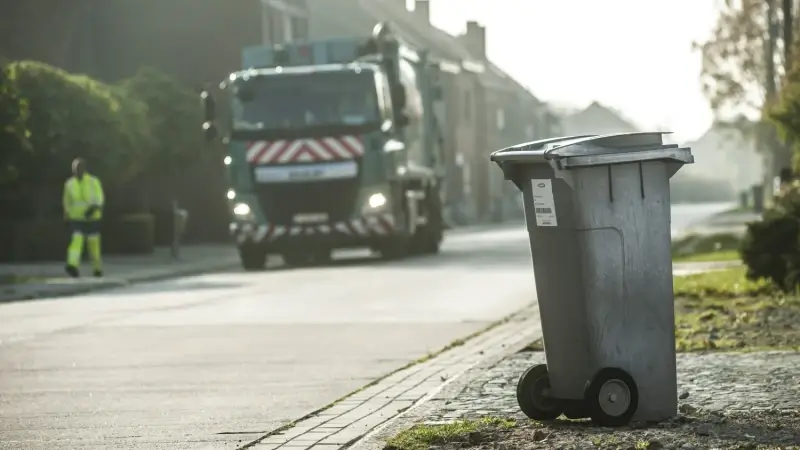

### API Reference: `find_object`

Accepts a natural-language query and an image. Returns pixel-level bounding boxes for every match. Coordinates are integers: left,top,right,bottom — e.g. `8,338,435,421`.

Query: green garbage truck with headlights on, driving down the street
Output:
201,23,444,270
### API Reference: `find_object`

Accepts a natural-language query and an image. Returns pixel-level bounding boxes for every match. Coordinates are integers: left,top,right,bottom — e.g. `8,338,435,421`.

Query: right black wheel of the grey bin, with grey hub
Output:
584,367,639,427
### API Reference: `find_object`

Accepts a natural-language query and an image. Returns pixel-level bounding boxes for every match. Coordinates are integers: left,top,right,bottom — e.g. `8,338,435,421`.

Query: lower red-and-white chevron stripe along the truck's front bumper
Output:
231,214,395,244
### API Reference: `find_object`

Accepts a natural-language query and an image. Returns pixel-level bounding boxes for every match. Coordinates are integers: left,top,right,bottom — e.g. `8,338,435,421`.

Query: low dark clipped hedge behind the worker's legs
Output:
0,214,154,262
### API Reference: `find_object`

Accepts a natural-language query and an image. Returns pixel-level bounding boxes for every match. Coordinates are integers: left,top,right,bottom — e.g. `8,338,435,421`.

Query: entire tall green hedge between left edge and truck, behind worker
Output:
0,61,227,250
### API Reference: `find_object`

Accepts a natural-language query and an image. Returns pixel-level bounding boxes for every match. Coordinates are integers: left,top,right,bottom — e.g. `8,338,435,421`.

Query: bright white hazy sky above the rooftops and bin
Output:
428,0,718,140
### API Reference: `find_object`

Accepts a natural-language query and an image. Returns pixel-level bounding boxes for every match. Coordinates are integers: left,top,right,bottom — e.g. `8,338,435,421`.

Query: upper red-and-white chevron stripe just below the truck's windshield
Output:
247,136,364,165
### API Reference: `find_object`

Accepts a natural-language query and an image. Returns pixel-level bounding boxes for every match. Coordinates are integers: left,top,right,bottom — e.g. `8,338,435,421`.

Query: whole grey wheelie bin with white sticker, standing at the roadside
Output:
491,133,694,426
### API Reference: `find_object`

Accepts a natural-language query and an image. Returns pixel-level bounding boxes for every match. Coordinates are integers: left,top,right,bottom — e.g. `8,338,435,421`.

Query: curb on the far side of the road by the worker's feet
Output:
0,260,238,304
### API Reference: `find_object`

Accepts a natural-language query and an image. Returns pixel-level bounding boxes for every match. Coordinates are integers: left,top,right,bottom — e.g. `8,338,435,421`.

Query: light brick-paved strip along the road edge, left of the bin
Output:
239,303,541,450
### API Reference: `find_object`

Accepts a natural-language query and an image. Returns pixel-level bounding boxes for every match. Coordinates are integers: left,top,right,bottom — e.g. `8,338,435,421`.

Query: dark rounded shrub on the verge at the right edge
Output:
741,183,800,291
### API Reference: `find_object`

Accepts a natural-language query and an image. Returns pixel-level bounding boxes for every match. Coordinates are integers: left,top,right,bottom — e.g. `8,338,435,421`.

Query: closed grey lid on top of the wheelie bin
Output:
490,132,694,169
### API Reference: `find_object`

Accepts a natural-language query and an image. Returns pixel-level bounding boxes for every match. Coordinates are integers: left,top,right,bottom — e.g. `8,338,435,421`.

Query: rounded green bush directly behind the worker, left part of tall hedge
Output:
2,61,153,216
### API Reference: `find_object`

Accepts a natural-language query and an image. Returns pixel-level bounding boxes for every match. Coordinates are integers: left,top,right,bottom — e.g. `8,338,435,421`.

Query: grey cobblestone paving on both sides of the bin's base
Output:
426,352,800,422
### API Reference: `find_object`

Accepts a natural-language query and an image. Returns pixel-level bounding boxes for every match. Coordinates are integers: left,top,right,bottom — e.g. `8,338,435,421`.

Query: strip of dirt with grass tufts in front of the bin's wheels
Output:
431,406,800,450
